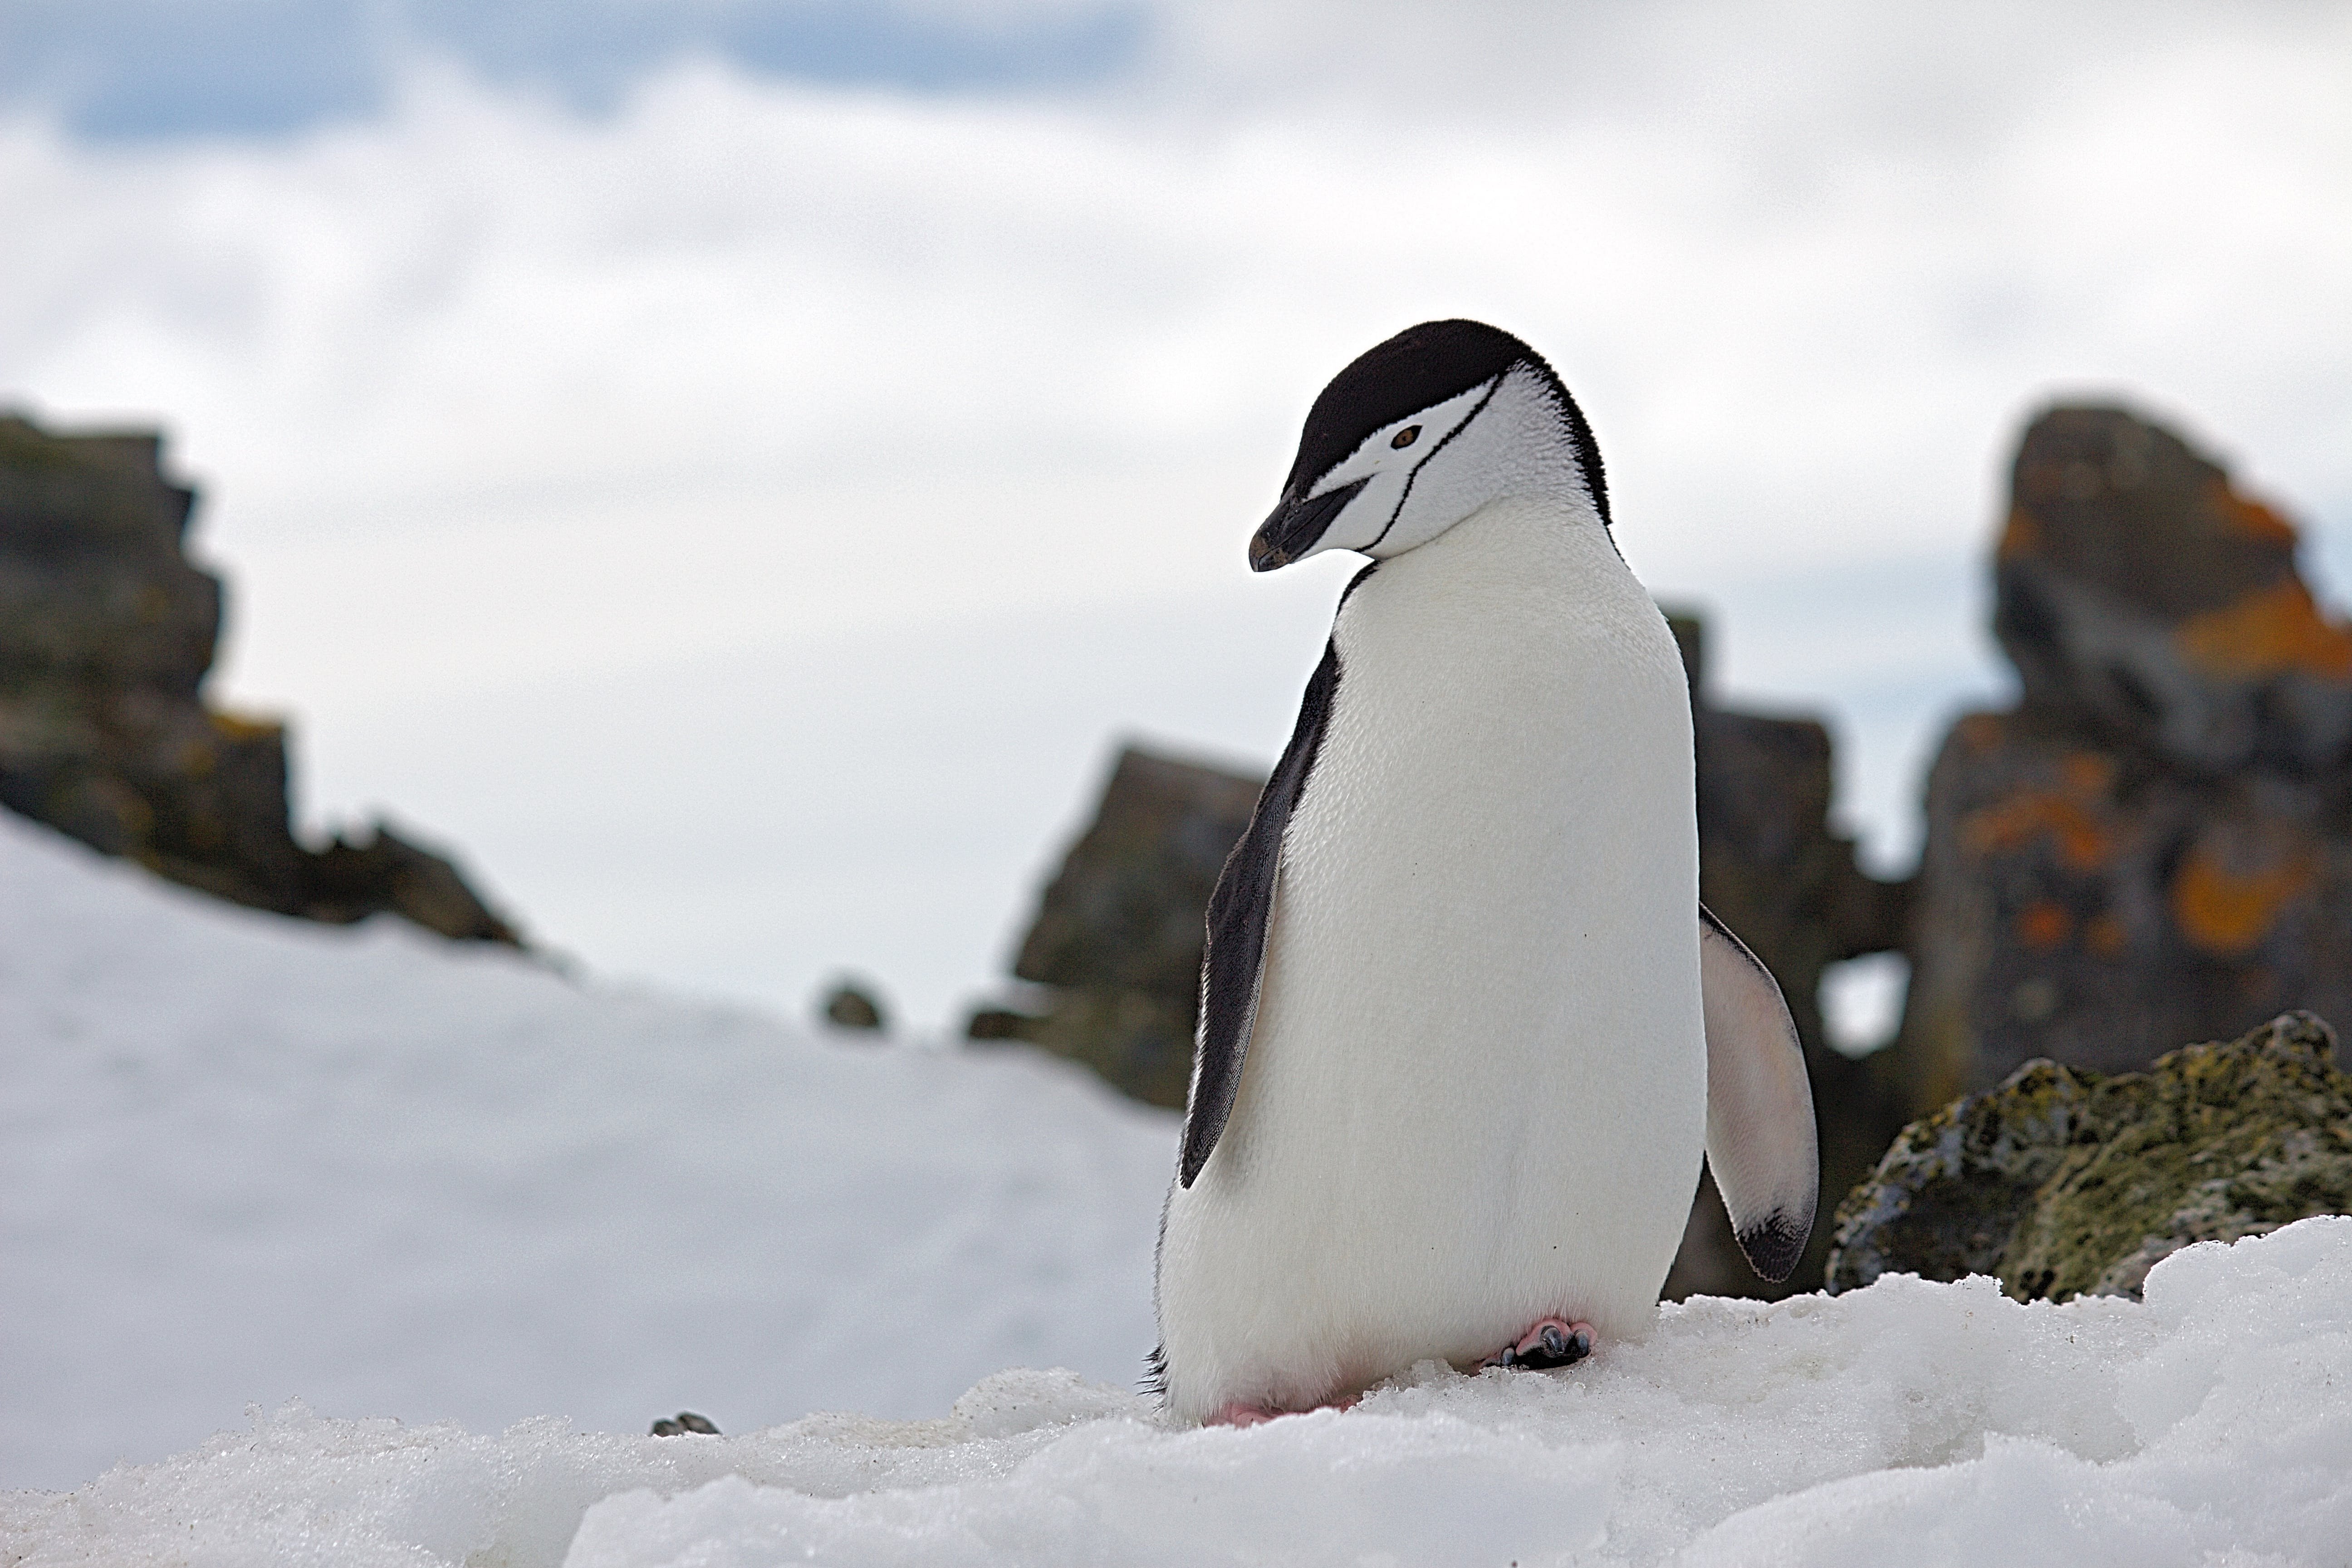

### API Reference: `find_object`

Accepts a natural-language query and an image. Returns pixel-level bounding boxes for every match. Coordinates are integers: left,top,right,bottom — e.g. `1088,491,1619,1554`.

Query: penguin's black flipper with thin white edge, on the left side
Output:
1178,644,1338,1187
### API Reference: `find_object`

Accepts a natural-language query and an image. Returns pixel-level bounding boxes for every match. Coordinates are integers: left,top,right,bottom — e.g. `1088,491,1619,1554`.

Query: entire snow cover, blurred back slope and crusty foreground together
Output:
0,808,2352,1568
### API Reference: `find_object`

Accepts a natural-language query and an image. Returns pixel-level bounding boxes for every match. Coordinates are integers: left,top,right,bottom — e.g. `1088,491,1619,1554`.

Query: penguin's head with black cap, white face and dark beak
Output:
1249,322,1609,571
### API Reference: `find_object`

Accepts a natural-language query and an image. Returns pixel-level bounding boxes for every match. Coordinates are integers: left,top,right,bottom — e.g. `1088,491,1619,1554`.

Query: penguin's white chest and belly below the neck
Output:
1160,501,1705,1403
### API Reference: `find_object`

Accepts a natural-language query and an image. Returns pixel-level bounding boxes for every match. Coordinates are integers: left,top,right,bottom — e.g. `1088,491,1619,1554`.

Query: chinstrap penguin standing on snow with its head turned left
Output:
1152,322,1818,1422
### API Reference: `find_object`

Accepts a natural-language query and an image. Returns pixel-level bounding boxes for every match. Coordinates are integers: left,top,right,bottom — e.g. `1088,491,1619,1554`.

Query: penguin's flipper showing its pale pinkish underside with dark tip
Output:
1698,905,1820,1284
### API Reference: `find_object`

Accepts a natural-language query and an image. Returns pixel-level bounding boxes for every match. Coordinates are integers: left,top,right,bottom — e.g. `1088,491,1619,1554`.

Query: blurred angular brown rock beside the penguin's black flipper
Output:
967,748,1265,1107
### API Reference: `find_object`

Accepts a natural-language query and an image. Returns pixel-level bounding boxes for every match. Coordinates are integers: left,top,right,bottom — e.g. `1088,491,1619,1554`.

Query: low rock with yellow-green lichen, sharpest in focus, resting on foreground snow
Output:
1828,1013,2352,1300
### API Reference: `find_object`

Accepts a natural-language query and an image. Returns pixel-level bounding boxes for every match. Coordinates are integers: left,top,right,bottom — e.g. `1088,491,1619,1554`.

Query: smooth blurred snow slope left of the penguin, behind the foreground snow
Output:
0,813,1176,1495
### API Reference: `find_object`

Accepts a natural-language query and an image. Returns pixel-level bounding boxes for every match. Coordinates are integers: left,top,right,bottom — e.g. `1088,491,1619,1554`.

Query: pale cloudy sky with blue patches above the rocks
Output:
0,0,2352,1029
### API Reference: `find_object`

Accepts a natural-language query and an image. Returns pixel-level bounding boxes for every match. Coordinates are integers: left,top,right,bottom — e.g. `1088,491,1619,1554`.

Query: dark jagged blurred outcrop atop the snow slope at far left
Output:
0,416,517,943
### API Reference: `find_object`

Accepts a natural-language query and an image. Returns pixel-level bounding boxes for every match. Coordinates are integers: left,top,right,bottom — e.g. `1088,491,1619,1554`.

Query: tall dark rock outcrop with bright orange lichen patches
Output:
1884,407,2352,1114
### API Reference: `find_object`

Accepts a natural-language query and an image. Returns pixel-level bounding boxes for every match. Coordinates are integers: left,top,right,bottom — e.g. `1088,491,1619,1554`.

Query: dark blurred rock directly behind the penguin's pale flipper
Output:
1665,611,1910,1300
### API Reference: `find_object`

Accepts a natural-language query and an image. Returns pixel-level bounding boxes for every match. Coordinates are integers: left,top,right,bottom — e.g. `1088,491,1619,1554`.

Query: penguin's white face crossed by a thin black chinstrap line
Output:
1254,369,1583,569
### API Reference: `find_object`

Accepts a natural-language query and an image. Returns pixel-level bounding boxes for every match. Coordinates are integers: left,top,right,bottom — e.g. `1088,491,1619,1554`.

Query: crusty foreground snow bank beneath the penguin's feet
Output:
0,1218,2352,1568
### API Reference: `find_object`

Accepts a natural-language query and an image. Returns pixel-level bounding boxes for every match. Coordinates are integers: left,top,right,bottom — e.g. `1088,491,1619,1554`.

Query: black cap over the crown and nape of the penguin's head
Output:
1282,320,1609,527
